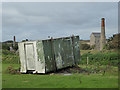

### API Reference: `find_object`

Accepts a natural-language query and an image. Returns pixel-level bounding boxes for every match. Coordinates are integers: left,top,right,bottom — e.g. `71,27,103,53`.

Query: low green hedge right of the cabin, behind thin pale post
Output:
80,53,120,65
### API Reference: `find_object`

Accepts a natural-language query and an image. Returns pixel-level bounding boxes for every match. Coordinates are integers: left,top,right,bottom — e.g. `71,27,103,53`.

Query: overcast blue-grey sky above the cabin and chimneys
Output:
2,2,118,41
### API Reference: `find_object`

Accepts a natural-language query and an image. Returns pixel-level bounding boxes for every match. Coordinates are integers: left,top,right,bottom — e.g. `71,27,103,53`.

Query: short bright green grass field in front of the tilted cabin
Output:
2,64,118,88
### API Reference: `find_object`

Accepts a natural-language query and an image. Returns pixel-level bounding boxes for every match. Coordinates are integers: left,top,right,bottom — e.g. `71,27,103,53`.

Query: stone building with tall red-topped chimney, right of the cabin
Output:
90,18,106,50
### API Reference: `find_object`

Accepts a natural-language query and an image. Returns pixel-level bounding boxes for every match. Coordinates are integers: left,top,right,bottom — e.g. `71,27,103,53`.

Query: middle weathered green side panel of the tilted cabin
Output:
54,38,74,69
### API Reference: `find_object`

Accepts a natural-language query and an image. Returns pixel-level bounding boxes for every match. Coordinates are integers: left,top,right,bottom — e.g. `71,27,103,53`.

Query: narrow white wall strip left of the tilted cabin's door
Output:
18,43,27,73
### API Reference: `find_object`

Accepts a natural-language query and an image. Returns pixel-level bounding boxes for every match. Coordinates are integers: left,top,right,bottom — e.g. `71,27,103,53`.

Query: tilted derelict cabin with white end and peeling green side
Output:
18,36,80,73
